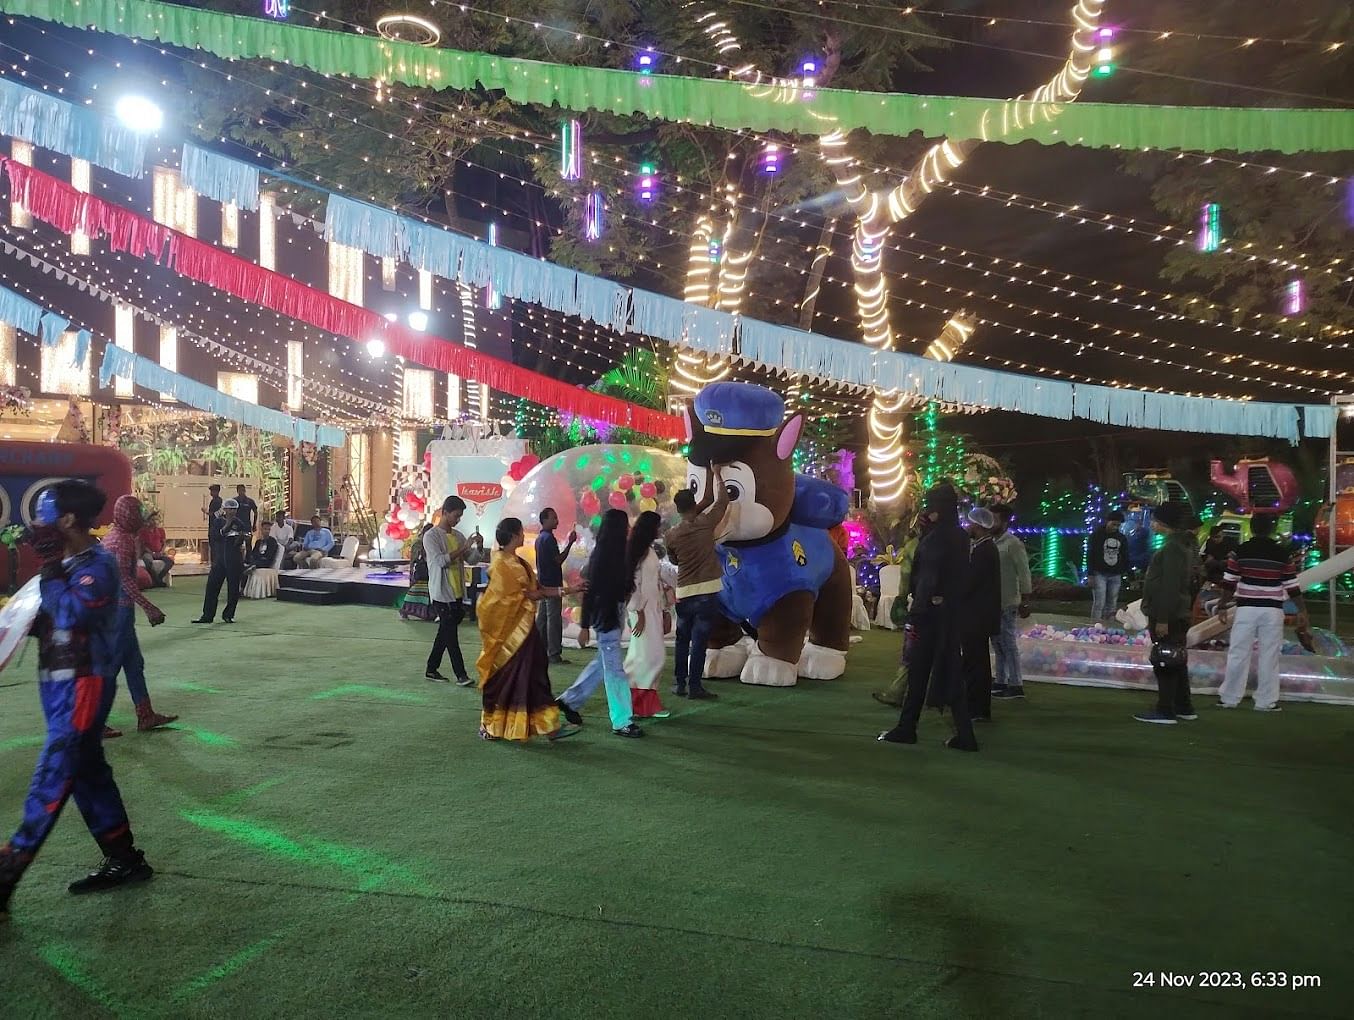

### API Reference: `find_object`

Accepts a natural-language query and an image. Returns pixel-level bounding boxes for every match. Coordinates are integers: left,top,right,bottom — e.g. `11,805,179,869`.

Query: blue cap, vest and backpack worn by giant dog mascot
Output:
692,383,849,627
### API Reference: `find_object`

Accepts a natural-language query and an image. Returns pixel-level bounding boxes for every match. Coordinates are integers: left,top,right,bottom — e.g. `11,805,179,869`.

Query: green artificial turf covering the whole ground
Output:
0,580,1354,1019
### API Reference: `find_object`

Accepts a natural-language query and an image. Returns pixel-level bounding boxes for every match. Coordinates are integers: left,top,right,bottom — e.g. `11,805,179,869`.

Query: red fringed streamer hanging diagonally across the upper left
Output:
0,157,685,439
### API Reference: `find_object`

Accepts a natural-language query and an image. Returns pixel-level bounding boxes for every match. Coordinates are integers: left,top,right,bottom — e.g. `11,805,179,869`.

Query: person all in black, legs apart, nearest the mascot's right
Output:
879,484,978,750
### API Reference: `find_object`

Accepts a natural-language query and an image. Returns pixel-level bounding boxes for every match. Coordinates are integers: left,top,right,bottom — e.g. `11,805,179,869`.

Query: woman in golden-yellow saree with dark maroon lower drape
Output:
477,517,578,741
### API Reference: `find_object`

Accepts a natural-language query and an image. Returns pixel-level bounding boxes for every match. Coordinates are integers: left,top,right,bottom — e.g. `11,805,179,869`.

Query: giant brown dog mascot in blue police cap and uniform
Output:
685,382,852,687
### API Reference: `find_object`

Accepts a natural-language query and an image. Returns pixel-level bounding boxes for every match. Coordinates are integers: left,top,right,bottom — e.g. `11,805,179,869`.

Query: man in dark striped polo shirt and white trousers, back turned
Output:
1217,513,1307,713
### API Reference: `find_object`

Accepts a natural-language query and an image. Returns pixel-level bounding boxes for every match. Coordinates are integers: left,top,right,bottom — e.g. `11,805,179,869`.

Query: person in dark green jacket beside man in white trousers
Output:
1133,503,1200,726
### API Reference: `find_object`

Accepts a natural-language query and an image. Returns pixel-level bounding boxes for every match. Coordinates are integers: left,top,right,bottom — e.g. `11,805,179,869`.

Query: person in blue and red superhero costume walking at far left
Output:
0,481,152,920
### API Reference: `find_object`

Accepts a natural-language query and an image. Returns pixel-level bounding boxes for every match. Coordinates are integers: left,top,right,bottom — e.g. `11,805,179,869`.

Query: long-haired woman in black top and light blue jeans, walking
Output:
558,509,645,737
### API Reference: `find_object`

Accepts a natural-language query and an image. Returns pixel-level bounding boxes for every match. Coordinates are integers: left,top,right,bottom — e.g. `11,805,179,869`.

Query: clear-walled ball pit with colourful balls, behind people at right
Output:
1020,622,1354,704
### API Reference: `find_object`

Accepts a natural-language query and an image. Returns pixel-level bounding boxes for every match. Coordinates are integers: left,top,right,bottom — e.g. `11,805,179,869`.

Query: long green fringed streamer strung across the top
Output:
0,0,1354,153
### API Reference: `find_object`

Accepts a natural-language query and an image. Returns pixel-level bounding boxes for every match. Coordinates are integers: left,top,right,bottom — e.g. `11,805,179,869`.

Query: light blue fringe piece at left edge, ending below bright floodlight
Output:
0,79,150,177
